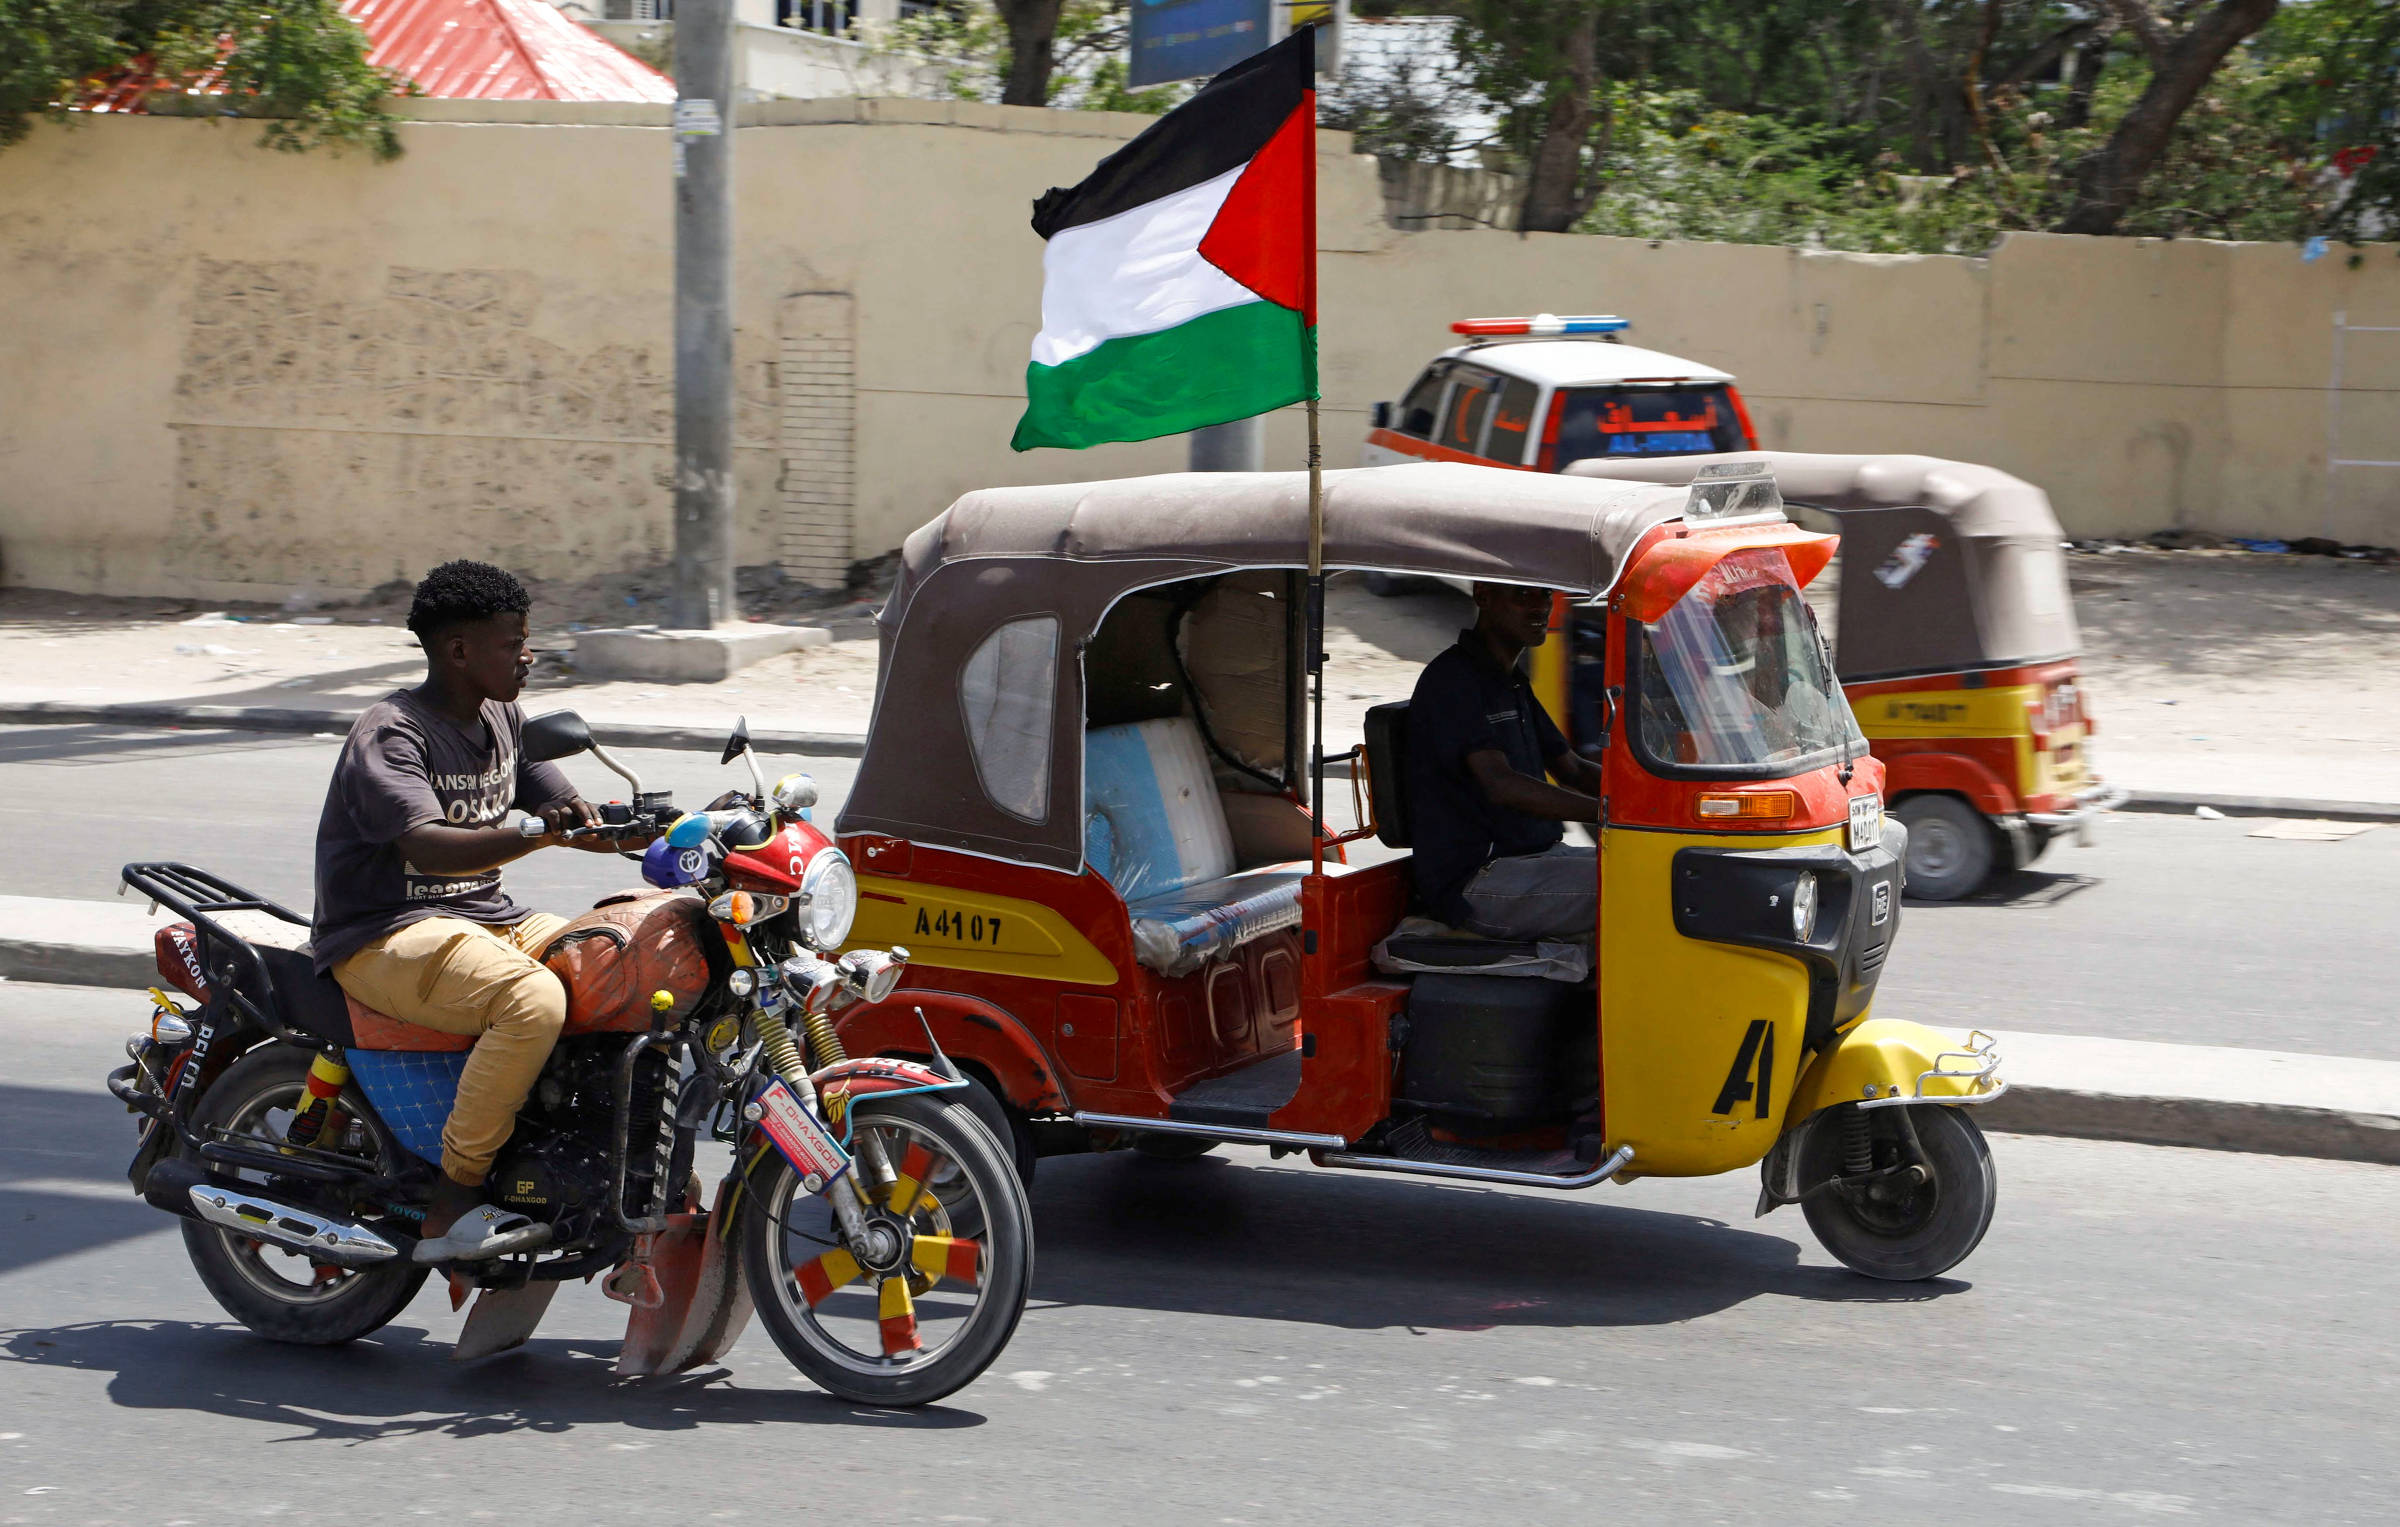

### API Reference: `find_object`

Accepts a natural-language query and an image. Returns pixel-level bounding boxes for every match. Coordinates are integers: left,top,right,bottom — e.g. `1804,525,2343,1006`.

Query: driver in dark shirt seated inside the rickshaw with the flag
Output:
1406,583,1601,939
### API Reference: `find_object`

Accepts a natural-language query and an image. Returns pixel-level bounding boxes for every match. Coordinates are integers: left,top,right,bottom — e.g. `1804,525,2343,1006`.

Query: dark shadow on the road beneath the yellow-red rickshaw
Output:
1034,1152,1970,1330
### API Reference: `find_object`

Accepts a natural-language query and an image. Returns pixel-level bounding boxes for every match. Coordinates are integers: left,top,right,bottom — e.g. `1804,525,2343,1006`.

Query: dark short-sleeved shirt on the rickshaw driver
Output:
1406,631,1567,927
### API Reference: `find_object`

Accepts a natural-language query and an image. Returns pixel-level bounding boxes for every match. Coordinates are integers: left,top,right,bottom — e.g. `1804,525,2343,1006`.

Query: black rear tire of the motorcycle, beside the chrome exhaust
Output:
182,1044,427,1347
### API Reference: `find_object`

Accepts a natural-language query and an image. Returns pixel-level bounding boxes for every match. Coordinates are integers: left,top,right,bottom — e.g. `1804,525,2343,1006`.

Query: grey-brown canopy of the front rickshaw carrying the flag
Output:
838,463,1685,874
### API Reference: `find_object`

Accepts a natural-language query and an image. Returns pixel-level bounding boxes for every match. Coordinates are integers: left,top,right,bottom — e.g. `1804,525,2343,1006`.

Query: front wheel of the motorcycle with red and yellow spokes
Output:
739,1095,1034,1407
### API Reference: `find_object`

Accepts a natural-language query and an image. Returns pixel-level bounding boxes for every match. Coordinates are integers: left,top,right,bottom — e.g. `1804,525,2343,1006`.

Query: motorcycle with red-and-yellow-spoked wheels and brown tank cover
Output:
108,711,1034,1405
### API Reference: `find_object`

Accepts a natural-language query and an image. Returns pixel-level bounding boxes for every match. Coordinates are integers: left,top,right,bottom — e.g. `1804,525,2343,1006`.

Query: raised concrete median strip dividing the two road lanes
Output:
0,896,2400,1164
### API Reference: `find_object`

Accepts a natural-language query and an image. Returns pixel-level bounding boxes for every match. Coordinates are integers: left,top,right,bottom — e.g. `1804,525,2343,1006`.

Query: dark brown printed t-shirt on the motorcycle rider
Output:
312,689,576,970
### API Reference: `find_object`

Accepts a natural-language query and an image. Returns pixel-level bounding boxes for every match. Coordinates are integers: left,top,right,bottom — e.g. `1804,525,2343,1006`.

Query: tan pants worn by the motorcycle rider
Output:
334,912,566,1186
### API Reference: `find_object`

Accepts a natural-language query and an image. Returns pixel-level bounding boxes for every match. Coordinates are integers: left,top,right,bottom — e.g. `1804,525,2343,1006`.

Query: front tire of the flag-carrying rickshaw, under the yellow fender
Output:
1800,1102,1999,1282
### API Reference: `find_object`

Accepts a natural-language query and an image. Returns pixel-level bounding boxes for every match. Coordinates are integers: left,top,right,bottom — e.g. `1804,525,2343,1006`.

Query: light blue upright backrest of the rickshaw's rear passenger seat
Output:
1082,715,1234,903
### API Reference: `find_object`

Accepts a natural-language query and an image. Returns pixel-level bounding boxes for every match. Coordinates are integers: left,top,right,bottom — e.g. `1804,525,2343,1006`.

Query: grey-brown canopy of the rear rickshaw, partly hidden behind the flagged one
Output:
1567,451,2083,684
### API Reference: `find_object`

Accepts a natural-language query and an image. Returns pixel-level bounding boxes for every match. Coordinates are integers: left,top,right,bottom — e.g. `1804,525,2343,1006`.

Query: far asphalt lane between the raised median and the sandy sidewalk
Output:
0,727,2400,1059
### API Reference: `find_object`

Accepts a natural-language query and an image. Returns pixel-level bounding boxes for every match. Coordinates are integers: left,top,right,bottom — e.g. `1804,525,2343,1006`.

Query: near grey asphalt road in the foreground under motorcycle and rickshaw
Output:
0,984,2400,1527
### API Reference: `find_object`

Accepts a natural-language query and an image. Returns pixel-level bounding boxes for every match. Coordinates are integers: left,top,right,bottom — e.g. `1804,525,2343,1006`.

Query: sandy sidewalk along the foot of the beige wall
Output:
0,552,2400,809
